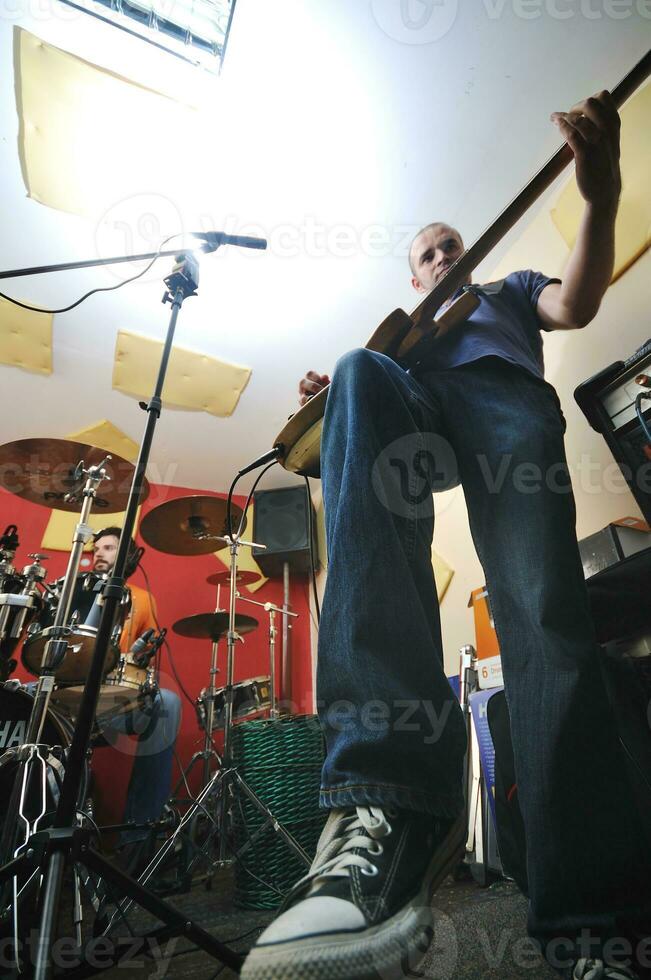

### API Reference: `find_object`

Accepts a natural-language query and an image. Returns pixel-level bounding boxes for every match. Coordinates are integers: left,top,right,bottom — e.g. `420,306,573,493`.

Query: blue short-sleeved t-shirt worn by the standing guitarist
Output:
417,269,560,378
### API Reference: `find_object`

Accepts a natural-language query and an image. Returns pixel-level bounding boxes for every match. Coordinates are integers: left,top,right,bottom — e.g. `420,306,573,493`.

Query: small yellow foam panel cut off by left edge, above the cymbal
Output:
0,298,52,374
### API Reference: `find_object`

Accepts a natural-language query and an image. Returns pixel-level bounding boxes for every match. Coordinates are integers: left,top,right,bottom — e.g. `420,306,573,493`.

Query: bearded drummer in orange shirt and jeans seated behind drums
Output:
93,527,181,844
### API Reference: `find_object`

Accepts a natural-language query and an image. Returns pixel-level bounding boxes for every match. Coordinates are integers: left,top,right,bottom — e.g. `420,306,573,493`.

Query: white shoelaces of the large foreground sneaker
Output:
286,806,398,903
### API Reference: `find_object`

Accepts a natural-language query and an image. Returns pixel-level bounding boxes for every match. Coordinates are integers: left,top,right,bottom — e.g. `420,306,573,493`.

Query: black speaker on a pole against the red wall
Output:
253,486,317,578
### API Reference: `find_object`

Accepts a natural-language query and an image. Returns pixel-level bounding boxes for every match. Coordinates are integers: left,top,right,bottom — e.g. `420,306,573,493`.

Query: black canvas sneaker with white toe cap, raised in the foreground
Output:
241,806,466,980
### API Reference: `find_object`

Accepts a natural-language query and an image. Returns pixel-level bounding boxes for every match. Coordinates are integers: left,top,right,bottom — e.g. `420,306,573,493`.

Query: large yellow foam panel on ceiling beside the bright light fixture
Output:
14,27,205,219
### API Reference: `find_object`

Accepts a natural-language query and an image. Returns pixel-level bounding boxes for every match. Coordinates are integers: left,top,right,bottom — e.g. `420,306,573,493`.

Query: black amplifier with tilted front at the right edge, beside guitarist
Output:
574,340,651,523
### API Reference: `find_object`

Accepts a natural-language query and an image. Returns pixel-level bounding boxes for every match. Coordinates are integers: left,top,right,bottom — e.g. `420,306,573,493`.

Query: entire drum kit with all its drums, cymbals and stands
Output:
0,439,304,936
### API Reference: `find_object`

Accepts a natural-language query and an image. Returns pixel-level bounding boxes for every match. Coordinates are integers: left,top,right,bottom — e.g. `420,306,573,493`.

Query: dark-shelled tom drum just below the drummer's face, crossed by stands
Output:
21,573,131,685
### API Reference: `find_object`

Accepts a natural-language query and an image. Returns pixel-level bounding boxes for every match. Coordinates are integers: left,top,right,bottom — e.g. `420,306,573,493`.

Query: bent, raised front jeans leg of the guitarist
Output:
317,350,466,817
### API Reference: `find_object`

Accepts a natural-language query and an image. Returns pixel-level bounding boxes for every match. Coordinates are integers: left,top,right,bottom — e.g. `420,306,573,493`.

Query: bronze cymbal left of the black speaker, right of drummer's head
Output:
140,494,246,555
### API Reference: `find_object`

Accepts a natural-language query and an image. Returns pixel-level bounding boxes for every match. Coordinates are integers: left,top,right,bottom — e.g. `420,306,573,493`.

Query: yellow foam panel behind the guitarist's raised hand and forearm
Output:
551,84,651,282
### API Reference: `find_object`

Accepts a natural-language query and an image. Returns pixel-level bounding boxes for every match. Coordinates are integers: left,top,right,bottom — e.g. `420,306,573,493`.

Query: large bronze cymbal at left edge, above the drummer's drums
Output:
0,439,149,514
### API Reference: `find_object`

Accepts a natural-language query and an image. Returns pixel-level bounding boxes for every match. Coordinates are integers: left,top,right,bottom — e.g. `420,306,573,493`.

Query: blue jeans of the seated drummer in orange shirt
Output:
101,688,181,842
